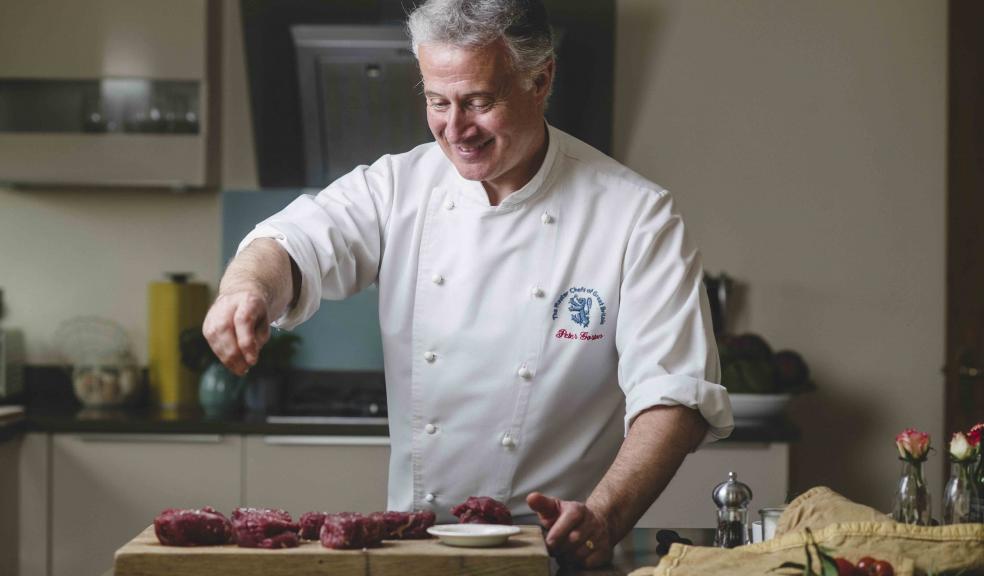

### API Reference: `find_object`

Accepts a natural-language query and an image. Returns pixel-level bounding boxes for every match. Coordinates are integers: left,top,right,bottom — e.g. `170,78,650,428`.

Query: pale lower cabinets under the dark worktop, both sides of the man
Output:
7,433,789,576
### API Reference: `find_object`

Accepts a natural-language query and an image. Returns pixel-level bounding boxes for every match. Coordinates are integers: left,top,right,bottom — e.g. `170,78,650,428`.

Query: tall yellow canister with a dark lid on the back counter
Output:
147,274,208,408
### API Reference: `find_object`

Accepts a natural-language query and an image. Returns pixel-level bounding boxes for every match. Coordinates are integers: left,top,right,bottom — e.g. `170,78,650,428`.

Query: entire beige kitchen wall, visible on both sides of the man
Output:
0,0,946,510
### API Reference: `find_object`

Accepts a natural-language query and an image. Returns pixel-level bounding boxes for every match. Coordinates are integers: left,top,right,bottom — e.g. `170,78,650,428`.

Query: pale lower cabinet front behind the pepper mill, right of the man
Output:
636,442,789,528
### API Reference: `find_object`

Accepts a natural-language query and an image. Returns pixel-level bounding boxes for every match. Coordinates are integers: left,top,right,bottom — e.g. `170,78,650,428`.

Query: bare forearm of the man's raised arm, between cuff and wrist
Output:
219,238,300,320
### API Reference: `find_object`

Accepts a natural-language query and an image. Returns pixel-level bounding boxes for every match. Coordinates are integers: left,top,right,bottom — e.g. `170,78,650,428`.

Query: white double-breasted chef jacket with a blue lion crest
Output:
239,127,734,521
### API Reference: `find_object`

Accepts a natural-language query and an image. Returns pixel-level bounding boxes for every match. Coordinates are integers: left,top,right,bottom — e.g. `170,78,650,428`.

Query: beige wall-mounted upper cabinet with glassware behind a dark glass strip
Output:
0,0,218,188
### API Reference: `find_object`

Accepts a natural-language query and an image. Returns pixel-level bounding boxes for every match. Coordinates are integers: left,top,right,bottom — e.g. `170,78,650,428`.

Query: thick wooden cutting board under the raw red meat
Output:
113,526,550,576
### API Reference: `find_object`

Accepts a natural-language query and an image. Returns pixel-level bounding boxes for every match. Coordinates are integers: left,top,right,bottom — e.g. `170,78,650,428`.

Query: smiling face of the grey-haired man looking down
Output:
417,42,553,194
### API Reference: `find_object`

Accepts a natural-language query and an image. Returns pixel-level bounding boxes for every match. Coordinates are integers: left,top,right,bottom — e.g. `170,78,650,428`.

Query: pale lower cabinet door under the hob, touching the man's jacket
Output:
245,436,389,519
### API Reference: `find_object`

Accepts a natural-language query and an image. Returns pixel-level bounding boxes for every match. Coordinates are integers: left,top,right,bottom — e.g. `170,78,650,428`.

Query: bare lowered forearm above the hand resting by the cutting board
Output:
587,406,707,544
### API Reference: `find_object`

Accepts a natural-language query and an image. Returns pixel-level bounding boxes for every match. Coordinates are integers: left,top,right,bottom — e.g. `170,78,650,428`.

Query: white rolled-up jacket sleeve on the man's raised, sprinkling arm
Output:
236,156,394,330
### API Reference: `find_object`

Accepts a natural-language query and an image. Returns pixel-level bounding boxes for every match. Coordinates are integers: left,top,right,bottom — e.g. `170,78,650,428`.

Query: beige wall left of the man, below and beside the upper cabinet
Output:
0,0,256,363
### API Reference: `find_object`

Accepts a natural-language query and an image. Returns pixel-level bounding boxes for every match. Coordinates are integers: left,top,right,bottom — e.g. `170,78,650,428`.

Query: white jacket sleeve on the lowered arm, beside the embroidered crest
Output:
615,191,734,441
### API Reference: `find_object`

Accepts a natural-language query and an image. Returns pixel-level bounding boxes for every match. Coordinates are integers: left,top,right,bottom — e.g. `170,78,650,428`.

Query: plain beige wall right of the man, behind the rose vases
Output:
615,0,946,512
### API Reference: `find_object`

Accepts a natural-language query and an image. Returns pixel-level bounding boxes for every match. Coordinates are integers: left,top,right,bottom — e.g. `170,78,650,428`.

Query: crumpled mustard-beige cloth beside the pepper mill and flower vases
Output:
630,487,984,576
